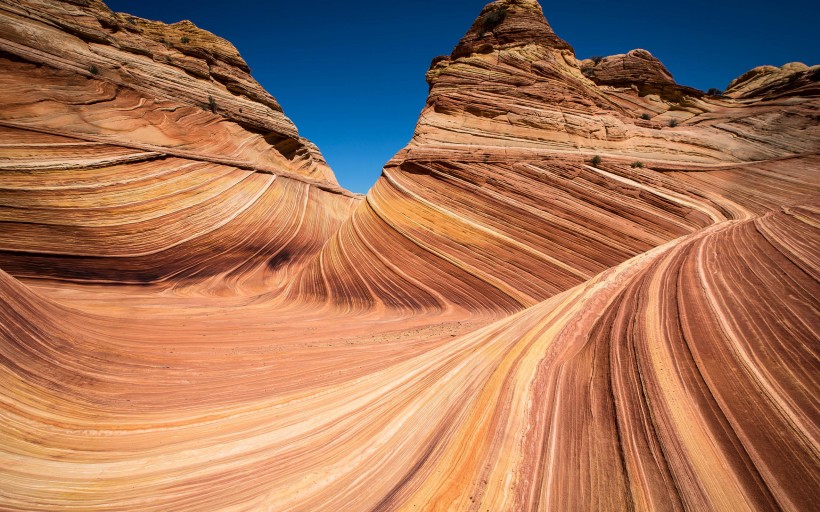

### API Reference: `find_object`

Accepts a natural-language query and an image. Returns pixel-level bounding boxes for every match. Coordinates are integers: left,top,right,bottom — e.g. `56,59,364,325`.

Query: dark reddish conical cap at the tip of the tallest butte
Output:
451,0,572,59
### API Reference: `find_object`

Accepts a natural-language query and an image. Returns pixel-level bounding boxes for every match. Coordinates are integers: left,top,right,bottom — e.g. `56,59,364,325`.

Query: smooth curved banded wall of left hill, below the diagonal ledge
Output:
0,125,356,289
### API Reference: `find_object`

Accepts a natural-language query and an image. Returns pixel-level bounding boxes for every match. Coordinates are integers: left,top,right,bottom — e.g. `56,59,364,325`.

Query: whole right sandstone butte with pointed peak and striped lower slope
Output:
292,1,820,313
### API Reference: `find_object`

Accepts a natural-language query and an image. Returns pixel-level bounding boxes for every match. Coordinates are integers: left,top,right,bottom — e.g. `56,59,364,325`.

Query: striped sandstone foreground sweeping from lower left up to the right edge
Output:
2,209,820,510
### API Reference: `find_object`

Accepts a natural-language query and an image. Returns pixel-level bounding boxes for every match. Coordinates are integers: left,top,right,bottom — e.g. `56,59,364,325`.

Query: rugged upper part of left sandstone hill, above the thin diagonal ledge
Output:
0,0,335,185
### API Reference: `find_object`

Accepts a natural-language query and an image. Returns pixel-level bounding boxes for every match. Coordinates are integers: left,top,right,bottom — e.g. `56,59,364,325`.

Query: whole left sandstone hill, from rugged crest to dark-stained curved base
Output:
0,0,359,286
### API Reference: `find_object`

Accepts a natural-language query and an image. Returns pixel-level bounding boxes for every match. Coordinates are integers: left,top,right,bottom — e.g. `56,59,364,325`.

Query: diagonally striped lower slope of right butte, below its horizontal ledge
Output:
300,151,820,312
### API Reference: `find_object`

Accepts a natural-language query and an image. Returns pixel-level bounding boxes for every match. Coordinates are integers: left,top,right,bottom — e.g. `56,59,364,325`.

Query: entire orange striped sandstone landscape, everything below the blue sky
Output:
0,0,820,511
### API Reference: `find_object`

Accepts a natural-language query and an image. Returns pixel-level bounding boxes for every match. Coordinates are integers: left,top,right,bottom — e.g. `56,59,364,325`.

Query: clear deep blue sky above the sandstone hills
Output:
107,0,820,192
